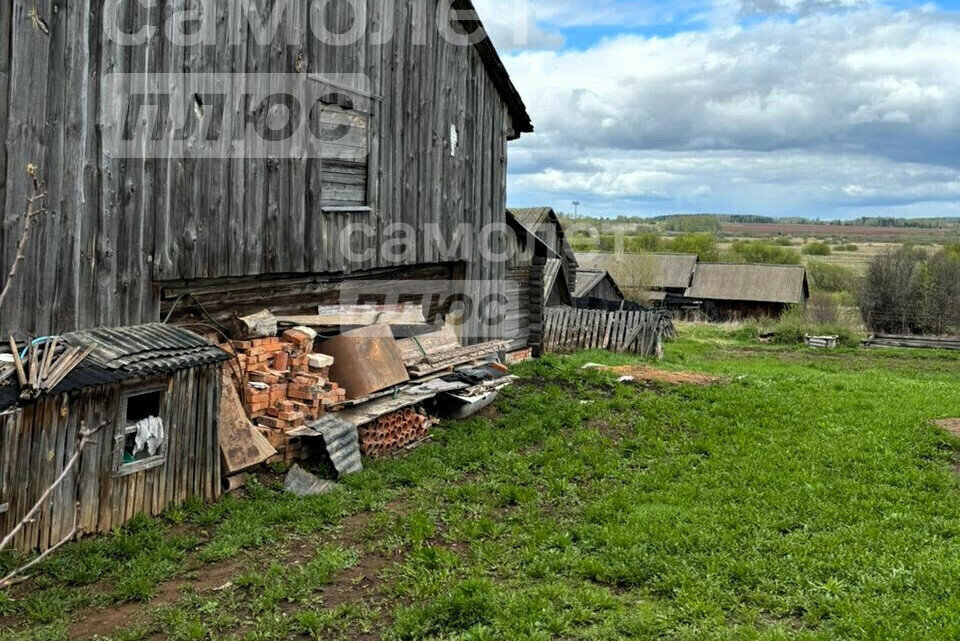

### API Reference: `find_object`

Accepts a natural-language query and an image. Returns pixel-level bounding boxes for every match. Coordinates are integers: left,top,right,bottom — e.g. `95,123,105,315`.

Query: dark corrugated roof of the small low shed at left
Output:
0,323,231,410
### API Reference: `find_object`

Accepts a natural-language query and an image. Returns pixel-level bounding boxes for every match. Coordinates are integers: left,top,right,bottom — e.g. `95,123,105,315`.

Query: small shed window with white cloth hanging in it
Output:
115,387,167,475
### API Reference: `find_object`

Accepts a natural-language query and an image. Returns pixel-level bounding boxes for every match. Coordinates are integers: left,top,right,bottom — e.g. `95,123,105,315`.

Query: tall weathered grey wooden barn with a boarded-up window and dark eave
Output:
0,0,532,340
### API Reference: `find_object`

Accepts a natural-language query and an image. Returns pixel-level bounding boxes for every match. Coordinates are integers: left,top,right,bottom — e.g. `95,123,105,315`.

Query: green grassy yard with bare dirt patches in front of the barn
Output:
0,327,960,640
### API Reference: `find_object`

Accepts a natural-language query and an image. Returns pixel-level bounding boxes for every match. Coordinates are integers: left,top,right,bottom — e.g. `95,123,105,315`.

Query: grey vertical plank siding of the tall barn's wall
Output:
0,0,512,336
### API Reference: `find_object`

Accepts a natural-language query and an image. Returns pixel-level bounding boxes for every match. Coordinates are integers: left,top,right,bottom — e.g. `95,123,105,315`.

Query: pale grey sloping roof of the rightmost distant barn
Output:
685,263,810,304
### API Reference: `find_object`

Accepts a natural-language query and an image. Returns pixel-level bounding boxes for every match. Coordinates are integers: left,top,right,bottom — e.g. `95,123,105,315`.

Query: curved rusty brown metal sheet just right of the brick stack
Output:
316,325,410,399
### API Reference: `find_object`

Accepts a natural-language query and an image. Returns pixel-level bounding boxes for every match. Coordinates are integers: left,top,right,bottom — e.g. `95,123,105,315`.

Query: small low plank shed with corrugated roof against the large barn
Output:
0,324,229,551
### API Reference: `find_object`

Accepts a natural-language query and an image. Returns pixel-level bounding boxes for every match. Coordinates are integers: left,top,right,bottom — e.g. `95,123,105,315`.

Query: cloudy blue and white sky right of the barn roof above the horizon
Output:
476,0,960,218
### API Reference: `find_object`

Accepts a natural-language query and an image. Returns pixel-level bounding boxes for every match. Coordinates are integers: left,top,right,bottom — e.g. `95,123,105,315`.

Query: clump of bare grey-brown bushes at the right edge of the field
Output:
860,244,960,334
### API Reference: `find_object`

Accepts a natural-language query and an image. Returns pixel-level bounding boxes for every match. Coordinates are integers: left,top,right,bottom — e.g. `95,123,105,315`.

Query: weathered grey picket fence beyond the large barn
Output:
543,307,676,357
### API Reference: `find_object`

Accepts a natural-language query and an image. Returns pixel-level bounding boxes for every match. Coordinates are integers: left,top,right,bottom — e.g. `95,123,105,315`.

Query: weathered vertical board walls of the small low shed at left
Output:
0,366,220,551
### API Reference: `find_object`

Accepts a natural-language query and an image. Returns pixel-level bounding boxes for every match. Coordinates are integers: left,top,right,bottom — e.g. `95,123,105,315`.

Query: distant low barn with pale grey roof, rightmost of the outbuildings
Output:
684,263,810,321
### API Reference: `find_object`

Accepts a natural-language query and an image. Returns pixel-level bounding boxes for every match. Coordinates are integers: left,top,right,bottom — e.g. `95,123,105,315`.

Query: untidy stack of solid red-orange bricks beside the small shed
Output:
231,328,346,460
